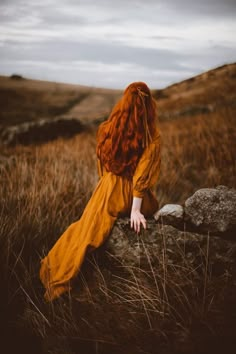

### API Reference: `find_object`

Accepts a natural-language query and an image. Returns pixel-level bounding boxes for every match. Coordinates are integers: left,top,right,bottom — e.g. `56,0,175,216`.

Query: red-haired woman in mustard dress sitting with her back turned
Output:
40,82,161,301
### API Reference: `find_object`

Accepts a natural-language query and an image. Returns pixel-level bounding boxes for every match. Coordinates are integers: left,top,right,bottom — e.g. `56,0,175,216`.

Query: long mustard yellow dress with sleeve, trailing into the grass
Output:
40,131,161,301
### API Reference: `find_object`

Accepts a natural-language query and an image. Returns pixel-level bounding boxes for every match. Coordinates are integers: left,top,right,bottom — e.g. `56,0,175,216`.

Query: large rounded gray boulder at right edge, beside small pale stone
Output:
184,185,236,235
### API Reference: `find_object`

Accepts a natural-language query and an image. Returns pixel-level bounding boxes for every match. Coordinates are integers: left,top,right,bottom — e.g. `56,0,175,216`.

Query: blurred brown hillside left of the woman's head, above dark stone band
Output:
0,76,121,127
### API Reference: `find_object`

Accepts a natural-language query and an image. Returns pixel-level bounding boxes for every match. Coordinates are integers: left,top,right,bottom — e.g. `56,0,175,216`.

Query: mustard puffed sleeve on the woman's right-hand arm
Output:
133,131,161,198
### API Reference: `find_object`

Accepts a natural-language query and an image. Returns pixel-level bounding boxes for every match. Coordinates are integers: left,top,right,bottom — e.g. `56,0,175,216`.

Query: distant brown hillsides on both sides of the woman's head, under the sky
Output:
0,63,236,126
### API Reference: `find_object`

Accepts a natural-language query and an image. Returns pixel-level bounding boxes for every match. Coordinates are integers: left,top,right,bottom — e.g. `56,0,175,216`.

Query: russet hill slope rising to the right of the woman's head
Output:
153,63,236,121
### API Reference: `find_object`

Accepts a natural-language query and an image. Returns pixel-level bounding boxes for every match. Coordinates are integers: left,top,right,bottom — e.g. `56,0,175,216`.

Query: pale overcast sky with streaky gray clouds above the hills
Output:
0,0,236,89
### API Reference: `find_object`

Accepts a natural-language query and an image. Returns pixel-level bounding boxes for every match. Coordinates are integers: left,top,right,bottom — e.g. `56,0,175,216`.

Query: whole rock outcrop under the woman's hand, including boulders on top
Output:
105,186,236,268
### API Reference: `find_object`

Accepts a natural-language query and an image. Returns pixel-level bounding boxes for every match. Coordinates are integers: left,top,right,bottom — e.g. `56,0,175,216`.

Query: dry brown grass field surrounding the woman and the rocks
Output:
0,97,236,354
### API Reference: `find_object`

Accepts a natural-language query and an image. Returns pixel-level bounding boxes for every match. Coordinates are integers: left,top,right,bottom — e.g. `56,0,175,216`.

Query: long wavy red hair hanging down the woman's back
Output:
96,81,157,178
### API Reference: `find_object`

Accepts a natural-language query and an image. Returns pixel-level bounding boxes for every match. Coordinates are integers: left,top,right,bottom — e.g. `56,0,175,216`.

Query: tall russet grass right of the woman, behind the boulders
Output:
157,108,236,204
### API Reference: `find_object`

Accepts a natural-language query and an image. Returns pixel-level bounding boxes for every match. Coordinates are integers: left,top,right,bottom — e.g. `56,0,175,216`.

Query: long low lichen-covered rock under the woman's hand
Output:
105,218,236,272
